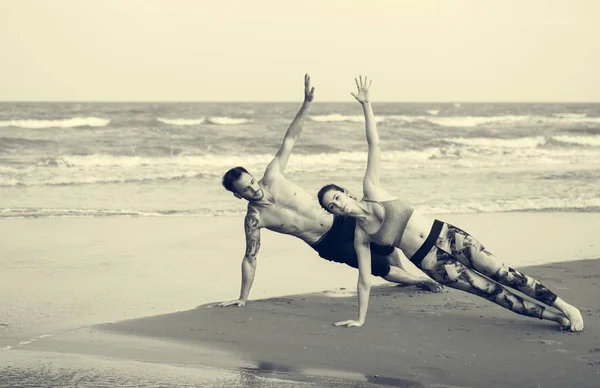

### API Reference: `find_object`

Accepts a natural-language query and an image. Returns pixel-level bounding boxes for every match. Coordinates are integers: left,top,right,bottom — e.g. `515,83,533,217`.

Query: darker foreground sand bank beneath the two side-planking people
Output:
5,259,600,387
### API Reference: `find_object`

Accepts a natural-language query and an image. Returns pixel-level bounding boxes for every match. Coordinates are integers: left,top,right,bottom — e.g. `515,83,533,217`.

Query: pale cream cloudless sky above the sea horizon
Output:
0,0,600,102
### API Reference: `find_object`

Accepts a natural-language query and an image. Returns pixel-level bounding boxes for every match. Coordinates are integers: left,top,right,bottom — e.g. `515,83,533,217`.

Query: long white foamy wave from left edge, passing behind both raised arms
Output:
0,148,439,187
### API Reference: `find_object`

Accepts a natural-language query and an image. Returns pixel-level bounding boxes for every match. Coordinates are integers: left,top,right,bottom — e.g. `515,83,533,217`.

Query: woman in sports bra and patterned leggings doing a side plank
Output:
318,76,583,332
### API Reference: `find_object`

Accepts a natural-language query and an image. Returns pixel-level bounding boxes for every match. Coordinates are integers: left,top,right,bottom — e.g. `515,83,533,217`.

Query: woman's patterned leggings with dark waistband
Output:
420,221,557,318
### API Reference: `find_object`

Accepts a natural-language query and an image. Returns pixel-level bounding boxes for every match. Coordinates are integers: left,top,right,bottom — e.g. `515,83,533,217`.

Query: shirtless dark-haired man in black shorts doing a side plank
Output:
219,74,442,307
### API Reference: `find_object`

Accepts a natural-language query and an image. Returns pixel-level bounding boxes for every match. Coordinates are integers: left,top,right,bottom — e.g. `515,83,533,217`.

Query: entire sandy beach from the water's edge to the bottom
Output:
0,213,600,387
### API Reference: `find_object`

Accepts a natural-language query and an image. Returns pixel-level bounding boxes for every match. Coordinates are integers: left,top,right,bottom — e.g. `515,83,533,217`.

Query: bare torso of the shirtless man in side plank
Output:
248,173,333,244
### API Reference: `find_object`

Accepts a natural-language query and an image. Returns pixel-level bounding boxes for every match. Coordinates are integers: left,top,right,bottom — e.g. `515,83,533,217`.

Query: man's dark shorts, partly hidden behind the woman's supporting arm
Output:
311,216,394,277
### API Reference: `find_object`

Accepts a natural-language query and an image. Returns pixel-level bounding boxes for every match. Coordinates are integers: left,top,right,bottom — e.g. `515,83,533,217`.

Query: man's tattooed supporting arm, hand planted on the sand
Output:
219,208,260,307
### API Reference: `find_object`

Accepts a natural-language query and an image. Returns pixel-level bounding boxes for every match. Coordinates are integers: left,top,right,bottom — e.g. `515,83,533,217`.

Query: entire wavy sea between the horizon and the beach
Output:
0,102,600,219
